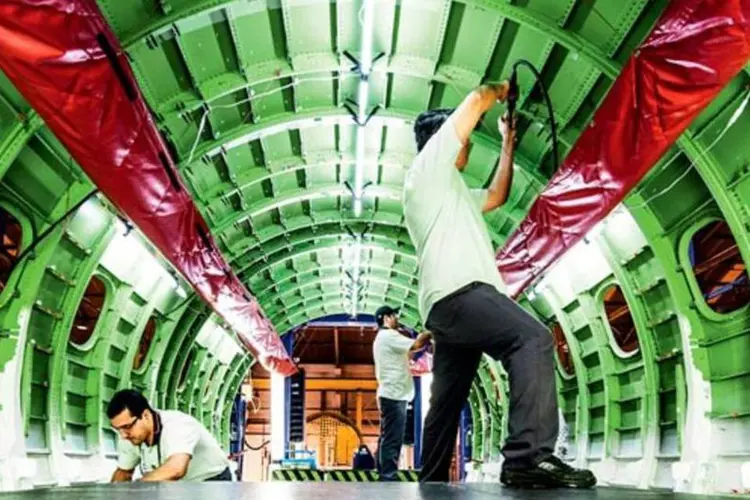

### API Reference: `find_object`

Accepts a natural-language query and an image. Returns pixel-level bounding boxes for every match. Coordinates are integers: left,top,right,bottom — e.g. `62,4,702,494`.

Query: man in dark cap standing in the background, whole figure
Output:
373,306,432,481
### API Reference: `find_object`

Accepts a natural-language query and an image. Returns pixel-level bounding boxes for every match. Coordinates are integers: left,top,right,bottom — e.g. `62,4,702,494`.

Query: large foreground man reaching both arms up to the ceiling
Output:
403,82,596,487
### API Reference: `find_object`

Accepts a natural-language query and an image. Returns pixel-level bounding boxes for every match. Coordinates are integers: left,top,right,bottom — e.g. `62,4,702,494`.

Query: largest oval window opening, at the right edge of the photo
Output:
688,221,750,314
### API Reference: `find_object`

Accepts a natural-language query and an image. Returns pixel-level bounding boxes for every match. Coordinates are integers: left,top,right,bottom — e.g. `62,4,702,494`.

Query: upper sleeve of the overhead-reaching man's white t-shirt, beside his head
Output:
414,115,463,189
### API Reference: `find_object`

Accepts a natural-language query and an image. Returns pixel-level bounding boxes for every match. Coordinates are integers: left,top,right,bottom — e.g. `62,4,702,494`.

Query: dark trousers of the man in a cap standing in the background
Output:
378,398,406,481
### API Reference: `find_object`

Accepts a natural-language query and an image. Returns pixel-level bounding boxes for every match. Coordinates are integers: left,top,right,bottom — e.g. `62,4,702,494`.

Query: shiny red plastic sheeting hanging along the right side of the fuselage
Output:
496,0,750,296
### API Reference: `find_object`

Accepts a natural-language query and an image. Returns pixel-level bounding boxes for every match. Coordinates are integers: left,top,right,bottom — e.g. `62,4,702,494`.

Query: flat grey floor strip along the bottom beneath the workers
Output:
0,482,730,500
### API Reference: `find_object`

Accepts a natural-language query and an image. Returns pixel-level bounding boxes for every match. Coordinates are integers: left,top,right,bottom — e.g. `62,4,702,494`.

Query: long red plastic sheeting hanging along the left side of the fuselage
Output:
0,0,296,375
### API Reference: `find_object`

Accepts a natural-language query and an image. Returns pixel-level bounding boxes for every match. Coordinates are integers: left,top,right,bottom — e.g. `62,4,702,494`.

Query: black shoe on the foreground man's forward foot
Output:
500,456,596,488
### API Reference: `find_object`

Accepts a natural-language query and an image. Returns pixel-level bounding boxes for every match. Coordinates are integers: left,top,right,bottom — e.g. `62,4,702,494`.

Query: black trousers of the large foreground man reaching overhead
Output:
420,283,558,482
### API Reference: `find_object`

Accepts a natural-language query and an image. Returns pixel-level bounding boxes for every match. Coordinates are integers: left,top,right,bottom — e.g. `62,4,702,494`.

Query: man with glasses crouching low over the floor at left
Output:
107,389,234,482
